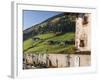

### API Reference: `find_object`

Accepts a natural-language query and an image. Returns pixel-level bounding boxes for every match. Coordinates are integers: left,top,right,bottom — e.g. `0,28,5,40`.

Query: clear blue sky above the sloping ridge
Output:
23,10,61,30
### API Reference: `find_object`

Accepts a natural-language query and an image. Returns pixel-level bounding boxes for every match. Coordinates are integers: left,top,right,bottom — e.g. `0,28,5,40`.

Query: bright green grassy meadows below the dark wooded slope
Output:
24,32,75,54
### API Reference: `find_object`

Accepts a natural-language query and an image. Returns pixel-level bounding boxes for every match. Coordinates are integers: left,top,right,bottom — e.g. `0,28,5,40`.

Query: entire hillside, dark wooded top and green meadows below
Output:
23,13,75,54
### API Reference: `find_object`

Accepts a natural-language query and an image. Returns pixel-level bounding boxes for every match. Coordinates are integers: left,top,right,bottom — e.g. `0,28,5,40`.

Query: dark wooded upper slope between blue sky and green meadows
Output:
23,13,76,40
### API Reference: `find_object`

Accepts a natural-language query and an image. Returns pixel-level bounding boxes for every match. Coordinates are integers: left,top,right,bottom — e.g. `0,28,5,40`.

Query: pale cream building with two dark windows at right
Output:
75,13,91,51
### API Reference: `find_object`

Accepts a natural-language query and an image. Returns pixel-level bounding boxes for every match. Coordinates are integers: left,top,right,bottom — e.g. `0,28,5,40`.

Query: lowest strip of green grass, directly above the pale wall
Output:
27,45,74,54
